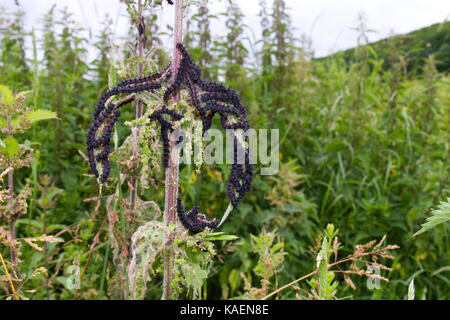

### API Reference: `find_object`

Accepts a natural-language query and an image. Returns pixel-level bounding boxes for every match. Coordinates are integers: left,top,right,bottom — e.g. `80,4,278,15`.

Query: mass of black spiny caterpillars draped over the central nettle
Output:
87,43,254,232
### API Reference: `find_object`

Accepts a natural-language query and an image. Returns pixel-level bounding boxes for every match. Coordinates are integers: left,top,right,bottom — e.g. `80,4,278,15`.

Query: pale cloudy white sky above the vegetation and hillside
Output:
0,0,450,57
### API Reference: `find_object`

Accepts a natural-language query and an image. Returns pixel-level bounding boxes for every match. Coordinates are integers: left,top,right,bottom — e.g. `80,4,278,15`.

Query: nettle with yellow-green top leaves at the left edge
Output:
0,85,62,299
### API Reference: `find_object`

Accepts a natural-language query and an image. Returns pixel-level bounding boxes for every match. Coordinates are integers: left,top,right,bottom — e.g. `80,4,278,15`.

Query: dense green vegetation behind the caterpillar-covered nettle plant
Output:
0,0,450,299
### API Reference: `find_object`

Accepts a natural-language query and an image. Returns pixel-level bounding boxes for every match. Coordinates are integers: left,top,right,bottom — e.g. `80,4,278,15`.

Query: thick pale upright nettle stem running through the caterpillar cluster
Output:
163,0,183,300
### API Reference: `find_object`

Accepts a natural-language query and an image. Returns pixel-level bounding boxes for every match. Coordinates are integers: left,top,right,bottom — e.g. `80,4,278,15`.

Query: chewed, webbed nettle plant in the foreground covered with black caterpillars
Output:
86,0,254,299
